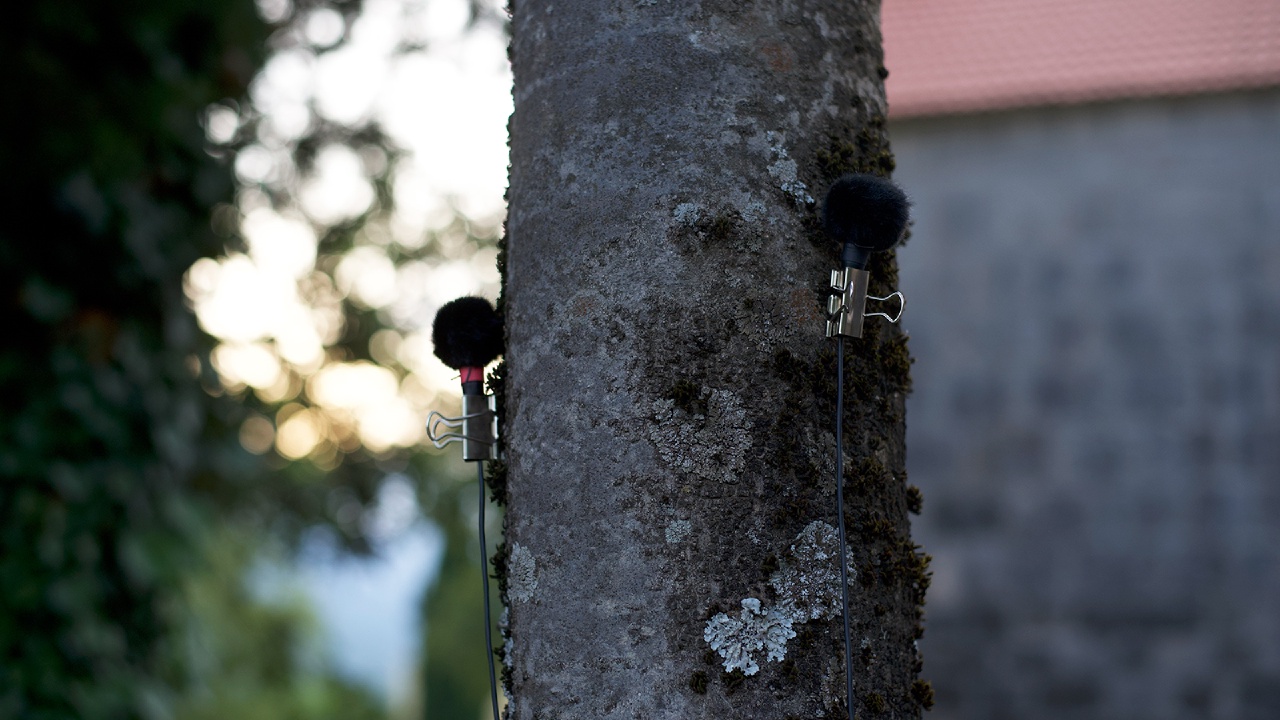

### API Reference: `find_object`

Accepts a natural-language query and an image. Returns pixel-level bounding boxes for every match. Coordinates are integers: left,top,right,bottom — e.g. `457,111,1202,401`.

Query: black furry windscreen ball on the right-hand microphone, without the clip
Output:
822,173,910,252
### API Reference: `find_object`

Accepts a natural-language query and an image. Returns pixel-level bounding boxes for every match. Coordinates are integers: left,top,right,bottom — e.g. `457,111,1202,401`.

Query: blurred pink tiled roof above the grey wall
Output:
881,0,1280,118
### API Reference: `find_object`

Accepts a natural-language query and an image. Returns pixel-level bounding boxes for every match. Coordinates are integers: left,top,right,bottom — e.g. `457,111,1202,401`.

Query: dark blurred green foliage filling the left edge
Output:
0,0,389,720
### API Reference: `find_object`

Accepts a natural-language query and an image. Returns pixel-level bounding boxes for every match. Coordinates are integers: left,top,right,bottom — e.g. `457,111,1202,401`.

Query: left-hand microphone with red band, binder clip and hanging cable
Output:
426,292,503,720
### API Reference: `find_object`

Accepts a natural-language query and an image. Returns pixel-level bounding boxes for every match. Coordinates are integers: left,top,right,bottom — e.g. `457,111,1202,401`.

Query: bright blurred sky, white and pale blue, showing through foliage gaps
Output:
199,0,512,703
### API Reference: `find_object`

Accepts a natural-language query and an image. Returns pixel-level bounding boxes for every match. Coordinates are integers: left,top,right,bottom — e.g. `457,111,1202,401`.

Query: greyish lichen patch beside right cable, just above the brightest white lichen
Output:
769,520,855,623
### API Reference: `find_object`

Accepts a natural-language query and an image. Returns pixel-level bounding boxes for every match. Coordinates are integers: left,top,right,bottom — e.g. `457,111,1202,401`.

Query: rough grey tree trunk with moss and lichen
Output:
492,0,932,720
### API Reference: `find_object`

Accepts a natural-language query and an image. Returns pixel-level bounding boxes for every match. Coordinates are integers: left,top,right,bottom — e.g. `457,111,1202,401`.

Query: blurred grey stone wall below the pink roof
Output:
891,91,1280,720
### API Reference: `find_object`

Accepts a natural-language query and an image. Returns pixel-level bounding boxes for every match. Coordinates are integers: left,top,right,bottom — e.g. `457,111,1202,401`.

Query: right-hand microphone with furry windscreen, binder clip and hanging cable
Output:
822,174,910,720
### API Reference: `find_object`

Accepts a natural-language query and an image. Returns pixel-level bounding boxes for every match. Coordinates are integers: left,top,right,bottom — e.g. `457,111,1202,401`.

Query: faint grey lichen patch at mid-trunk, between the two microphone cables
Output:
648,387,753,483
